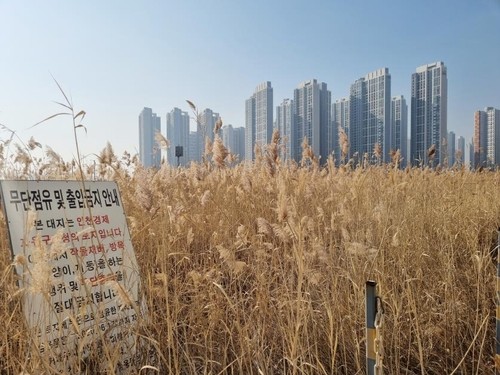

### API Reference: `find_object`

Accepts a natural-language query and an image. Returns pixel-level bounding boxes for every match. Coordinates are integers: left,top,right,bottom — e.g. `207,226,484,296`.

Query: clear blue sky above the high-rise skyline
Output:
0,0,500,163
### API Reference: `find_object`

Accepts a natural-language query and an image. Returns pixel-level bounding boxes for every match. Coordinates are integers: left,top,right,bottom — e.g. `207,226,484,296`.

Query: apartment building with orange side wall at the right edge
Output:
474,107,500,168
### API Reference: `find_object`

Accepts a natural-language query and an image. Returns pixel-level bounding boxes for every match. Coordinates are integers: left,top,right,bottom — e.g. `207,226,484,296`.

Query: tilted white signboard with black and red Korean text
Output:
0,181,142,373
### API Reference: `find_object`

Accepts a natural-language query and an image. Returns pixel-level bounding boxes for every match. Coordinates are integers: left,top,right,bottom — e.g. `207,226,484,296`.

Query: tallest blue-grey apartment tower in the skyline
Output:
410,61,448,165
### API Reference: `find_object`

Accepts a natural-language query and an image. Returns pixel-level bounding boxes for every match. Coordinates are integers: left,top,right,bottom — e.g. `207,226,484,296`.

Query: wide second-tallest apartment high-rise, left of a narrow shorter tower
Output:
349,68,391,162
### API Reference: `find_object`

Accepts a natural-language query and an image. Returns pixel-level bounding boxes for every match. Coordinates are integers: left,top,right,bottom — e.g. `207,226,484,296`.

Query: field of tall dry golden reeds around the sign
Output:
0,134,500,375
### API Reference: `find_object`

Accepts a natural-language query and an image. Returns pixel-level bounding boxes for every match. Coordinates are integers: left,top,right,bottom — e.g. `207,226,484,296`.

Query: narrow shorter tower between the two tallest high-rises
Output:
390,95,408,168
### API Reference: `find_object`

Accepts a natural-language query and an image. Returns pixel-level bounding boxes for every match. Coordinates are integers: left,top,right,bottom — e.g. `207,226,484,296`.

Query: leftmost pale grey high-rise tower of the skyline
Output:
139,107,161,168
